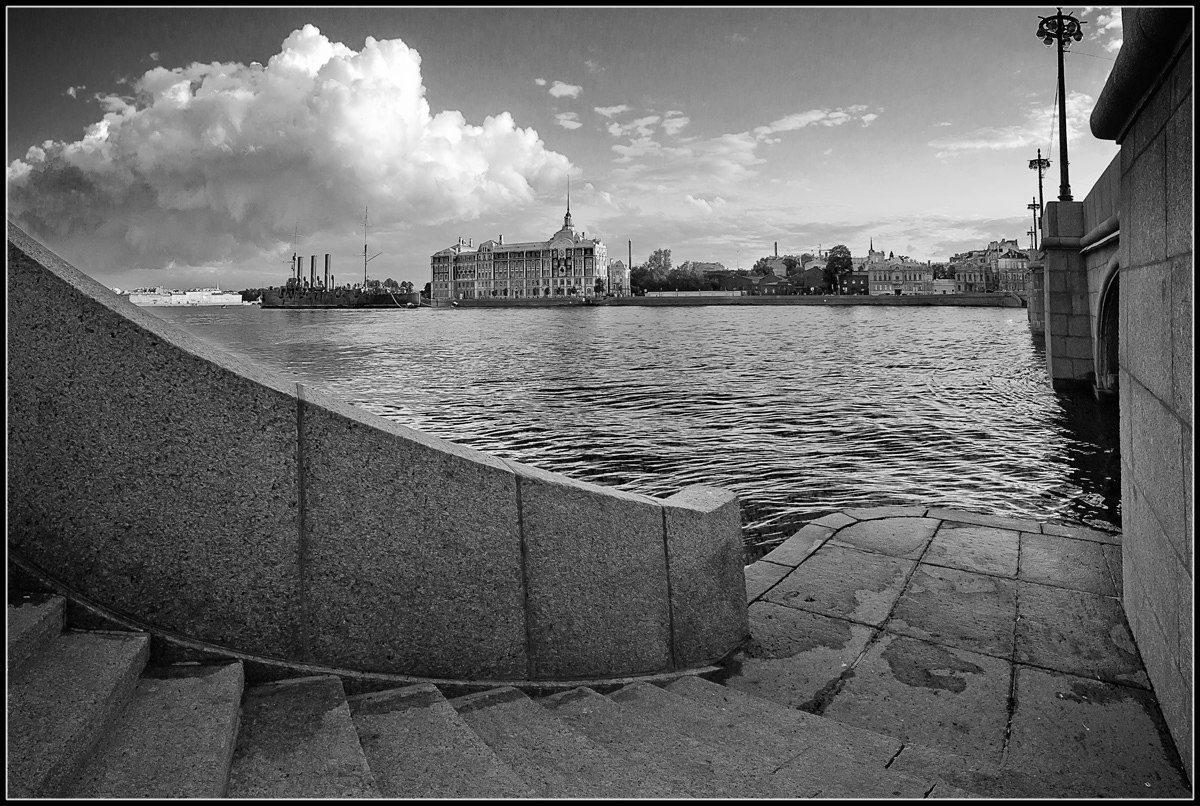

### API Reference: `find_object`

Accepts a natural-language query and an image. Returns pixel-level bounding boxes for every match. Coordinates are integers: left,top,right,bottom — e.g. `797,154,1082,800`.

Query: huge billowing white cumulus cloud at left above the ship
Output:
6,25,570,270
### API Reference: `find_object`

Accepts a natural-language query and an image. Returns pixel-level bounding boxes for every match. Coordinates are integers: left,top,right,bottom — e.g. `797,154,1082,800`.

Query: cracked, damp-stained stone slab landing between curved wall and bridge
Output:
724,506,1190,798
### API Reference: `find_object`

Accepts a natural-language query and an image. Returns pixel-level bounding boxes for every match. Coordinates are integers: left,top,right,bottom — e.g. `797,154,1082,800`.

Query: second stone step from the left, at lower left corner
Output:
7,631,150,798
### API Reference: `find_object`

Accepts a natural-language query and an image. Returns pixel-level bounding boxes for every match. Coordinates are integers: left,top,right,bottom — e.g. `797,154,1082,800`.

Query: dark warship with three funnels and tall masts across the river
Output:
263,207,420,308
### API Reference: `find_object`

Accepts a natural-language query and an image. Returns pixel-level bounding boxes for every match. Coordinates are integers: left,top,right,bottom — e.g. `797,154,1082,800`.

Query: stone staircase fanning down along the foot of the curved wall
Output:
7,595,966,798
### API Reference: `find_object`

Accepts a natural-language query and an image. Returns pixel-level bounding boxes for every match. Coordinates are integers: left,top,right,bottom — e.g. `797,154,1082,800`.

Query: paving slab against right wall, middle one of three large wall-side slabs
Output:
1014,582,1150,688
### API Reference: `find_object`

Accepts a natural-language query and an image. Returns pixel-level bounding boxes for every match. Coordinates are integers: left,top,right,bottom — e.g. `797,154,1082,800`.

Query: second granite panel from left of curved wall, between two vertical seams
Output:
302,390,525,679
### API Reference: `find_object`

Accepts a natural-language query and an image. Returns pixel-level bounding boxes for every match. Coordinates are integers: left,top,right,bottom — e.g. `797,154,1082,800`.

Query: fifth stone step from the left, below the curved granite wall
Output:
347,684,533,798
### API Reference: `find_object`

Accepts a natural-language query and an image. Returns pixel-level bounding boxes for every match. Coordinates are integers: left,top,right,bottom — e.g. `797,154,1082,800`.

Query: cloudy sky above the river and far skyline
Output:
6,6,1122,290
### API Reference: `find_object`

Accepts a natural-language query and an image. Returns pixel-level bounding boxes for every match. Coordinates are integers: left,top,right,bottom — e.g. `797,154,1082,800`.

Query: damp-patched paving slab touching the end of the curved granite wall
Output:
724,602,875,709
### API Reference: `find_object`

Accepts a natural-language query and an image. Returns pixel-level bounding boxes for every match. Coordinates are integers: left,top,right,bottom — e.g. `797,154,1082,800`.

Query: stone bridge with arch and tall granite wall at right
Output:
1028,8,1194,776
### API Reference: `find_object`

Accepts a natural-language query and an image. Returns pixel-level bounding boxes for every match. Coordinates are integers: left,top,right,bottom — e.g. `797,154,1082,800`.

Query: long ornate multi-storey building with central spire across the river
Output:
430,202,609,300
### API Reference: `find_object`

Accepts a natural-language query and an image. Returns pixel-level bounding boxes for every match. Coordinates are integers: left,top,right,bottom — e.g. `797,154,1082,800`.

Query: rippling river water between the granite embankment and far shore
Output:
146,306,1120,559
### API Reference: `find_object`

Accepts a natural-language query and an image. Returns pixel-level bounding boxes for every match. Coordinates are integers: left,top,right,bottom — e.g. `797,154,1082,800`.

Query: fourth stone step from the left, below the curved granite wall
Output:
227,675,379,798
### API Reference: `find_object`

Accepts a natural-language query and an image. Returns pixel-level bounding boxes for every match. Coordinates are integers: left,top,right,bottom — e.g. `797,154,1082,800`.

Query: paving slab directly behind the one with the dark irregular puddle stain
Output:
883,563,1016,658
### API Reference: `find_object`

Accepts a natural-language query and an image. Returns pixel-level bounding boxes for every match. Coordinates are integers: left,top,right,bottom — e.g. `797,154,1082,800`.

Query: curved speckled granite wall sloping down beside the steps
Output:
7,222,748,680
